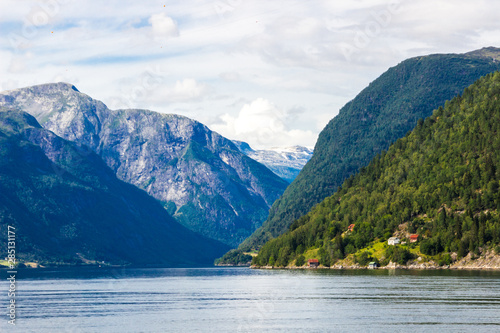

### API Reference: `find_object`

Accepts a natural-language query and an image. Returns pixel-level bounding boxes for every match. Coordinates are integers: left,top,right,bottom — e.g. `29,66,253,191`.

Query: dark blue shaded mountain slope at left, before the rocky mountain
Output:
0,108,228,266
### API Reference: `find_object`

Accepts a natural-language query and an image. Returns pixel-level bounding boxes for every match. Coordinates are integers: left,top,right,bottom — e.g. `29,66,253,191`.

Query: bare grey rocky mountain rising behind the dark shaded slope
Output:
0,83,288,247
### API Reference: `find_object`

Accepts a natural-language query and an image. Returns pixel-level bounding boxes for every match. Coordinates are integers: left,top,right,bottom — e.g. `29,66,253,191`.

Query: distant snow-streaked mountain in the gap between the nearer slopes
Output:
233,140,313,183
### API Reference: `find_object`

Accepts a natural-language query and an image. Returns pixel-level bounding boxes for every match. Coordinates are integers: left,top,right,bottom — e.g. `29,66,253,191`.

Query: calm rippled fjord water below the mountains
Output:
0,268,500,333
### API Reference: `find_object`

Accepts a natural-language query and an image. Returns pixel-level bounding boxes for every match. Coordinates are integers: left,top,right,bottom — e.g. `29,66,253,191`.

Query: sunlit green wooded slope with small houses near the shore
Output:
254,72,500,266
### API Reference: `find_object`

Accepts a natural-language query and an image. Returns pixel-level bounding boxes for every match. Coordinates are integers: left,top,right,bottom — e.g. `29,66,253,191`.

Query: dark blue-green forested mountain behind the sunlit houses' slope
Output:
234,47,500,251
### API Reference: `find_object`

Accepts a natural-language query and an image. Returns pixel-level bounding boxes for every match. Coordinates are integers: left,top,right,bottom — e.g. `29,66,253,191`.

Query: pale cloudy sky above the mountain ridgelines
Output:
0,0,500,149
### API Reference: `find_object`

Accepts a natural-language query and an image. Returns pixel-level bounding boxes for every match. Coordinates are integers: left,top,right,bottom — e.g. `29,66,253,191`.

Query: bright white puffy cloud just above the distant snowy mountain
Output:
210,98,316,149
